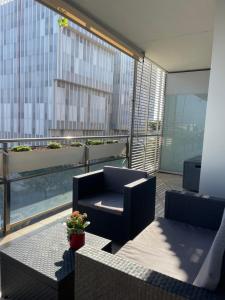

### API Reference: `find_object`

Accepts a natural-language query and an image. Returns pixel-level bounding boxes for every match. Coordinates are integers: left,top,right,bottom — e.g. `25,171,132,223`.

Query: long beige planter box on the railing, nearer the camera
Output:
0,147,85,176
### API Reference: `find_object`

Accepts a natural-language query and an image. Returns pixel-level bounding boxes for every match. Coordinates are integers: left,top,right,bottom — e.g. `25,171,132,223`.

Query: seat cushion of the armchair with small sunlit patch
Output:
78,192,123,213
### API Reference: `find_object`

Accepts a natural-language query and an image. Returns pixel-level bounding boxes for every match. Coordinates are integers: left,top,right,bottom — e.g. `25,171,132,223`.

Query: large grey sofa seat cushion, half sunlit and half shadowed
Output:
118,218,216,283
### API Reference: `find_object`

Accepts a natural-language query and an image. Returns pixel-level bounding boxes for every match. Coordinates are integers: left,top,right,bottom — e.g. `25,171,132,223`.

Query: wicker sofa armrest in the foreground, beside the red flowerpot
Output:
75,246,214,300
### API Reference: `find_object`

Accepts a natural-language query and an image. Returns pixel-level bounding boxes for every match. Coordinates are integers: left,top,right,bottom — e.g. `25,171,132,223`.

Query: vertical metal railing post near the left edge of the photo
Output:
3,143,10,235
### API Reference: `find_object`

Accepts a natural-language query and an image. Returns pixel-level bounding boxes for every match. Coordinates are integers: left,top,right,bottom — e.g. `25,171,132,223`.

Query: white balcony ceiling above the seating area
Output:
70,0,216,71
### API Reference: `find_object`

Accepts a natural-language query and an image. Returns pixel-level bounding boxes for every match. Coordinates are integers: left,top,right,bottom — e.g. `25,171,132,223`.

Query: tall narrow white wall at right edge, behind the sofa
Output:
200,0,225,197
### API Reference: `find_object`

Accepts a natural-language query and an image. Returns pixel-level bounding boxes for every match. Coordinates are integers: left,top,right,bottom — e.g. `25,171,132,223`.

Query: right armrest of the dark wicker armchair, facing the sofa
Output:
124,177,156,239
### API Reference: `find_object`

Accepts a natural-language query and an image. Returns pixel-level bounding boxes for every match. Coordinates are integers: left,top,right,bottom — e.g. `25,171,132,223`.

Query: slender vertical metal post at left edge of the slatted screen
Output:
128,60,138,169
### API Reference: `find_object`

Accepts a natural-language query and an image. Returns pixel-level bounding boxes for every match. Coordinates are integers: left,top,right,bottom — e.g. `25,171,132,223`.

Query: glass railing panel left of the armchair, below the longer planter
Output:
10,167,85,223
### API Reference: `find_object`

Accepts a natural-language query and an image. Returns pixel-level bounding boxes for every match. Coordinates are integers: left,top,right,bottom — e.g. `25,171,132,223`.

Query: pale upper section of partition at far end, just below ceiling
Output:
166,71,210,95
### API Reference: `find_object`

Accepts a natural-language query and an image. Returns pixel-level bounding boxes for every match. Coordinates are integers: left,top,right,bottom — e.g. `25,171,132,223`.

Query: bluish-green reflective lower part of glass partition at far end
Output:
160,94,207,173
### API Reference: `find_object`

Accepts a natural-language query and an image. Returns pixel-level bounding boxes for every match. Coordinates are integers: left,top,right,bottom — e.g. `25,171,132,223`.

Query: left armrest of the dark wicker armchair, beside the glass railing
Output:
73,170,104,210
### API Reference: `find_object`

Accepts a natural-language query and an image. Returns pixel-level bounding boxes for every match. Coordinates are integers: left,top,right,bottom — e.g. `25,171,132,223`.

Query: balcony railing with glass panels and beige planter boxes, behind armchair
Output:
0,136,128,228
